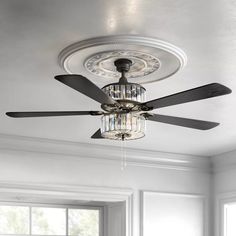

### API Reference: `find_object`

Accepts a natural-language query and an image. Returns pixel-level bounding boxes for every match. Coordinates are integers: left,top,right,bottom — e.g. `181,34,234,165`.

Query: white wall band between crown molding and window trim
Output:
0,142,210,236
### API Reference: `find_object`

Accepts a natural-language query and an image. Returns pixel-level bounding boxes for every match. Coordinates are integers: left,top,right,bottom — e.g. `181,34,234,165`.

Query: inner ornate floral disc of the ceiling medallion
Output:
84,51,160,79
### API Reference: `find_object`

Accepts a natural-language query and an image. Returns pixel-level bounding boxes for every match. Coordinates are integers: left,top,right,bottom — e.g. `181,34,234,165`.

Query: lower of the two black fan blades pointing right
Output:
147,114,219,130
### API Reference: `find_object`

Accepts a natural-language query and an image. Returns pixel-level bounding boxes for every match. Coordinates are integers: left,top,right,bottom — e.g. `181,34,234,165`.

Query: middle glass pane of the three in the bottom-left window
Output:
32,207,66,235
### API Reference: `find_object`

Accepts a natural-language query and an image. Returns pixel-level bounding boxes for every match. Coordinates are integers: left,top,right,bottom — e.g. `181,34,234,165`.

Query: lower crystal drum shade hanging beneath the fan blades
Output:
101,113,146,140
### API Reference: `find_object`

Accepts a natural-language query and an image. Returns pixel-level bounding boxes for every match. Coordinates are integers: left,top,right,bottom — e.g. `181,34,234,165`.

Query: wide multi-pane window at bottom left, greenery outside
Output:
0,205,102,236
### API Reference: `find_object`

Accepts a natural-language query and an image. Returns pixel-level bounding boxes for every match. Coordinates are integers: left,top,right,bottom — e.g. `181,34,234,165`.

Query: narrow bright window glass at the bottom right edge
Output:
224,203,236,236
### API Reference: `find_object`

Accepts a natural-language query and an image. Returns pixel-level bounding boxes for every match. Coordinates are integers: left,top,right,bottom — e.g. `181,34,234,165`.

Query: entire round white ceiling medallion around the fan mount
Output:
59,35,187,84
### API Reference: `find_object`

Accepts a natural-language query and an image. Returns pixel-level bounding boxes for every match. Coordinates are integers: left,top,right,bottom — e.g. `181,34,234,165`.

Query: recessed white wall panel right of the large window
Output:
143,191,207,236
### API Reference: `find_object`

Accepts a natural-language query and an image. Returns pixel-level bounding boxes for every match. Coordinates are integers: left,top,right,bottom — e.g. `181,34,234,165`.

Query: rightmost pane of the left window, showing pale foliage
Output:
68,209,99,236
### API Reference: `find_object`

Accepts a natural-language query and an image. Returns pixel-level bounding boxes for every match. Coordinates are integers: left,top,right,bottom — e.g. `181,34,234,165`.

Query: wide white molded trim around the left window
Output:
0,182,133,236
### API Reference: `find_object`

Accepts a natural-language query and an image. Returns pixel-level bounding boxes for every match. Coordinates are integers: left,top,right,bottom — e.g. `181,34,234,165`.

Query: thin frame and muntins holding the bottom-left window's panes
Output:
0,201,105,236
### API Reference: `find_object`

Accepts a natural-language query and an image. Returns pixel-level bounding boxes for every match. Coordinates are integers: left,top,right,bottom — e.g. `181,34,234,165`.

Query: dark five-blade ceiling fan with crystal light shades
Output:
6,58,231,140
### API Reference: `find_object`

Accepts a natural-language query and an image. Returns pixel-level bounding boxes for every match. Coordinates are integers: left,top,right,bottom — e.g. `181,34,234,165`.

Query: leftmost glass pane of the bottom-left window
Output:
0,206,29,234
